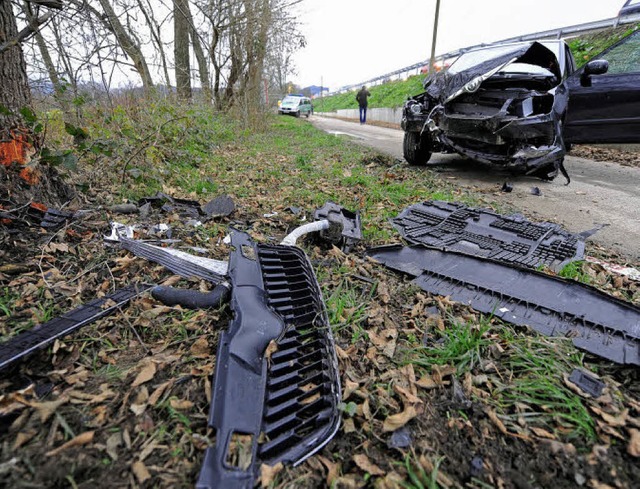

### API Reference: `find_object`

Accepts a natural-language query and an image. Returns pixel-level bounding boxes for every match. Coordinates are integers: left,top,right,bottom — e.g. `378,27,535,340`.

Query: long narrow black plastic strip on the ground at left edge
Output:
0,284,152,370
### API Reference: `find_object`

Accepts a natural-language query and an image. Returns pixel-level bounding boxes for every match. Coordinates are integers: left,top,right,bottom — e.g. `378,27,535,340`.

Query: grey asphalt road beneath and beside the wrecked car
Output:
311,116,640,265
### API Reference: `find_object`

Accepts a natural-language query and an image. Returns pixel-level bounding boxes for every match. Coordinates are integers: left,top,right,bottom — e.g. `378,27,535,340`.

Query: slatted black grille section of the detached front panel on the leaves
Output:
258,246,339,460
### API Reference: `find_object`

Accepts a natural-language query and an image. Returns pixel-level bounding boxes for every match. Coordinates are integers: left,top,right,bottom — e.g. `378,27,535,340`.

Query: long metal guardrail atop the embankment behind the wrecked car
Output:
327,14,640,95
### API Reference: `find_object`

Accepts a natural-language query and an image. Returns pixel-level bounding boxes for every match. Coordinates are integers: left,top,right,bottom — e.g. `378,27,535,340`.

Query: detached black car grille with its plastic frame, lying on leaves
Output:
197,232,340,488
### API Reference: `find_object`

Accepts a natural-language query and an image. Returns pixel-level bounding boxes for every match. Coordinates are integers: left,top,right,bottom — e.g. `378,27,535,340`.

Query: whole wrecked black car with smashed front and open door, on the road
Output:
401,32,640,180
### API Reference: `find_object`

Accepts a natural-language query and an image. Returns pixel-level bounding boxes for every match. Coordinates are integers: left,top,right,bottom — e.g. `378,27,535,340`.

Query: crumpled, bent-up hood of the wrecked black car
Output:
427,41,562,102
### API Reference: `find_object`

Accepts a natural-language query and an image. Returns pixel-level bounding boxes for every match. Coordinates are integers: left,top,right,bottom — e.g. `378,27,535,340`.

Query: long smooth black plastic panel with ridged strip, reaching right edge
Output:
367,246,640,365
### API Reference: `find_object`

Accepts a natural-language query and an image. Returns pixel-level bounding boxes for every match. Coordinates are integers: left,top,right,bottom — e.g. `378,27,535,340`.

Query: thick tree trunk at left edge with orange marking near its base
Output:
0,0,37,183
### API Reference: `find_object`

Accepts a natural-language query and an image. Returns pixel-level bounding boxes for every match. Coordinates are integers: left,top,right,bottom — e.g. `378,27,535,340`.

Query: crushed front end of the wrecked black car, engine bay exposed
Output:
402,41,567,179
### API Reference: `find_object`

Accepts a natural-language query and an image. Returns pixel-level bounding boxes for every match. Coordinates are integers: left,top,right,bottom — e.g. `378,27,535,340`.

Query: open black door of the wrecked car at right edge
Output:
564,31,640,143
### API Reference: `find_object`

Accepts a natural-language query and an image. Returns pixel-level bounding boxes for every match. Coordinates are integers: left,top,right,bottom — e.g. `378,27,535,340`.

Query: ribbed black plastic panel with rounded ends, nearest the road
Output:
392,201,584,270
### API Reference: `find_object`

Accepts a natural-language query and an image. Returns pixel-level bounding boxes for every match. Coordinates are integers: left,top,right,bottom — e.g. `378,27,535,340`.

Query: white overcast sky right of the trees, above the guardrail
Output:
293,0,624,89
